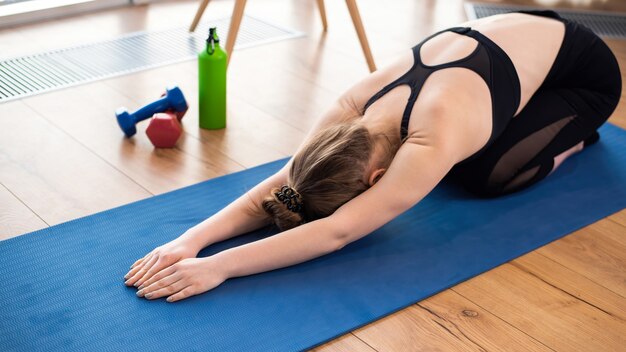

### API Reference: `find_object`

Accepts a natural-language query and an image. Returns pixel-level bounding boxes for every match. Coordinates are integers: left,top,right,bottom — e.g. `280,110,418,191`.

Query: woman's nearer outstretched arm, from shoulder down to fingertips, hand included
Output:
140,130,456,302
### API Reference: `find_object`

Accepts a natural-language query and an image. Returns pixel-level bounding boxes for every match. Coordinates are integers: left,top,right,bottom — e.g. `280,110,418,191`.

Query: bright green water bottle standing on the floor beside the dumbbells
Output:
198,27,228,129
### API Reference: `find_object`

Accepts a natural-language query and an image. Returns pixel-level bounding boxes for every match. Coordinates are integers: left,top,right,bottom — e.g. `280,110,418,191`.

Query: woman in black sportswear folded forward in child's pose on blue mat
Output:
125,11,621,302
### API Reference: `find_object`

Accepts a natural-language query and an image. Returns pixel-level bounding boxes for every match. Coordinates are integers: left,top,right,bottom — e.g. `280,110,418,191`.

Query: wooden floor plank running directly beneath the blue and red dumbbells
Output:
25,71,243,194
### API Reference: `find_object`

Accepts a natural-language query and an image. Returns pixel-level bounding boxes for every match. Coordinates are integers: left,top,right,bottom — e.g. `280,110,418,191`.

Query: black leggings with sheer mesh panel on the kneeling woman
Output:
452,14,622,197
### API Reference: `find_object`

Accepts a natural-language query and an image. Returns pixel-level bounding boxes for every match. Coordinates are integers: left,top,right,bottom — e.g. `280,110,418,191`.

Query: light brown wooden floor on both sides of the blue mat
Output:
0,0,626,352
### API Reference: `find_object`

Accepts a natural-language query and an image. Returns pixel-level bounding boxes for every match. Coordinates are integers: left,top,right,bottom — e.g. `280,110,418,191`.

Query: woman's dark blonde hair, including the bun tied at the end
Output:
262,123,393,231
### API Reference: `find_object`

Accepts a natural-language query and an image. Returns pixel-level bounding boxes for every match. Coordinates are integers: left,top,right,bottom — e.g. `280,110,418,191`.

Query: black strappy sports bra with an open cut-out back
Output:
363,27,520,152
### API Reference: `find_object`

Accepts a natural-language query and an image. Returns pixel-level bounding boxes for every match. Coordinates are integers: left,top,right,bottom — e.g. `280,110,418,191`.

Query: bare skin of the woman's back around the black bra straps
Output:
346,13,565,160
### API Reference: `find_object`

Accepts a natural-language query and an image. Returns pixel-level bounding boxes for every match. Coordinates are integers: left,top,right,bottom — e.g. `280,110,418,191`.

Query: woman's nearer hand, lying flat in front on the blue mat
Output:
137,256,228,302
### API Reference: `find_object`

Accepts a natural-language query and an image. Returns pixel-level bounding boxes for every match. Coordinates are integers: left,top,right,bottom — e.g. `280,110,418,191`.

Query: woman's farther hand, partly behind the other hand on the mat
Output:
124,239,199,286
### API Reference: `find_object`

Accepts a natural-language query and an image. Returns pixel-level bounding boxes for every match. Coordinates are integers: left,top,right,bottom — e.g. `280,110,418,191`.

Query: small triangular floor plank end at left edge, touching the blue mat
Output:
0,184,48,241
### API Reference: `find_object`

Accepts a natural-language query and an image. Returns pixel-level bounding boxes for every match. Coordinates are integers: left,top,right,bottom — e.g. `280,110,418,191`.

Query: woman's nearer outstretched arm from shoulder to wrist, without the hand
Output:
214,136,454,278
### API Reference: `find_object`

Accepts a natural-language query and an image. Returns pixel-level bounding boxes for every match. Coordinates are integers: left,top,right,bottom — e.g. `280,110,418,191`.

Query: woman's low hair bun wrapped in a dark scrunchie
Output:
262,186,304,231
